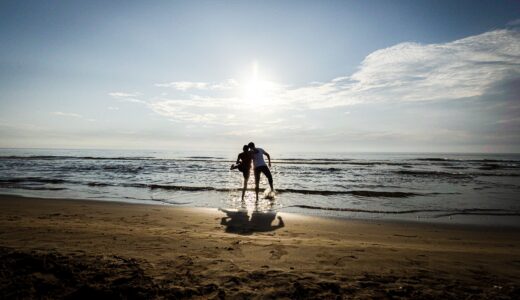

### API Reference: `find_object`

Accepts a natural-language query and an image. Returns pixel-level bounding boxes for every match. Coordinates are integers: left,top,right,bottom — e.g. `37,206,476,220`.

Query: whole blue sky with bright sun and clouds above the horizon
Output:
0,0,520,153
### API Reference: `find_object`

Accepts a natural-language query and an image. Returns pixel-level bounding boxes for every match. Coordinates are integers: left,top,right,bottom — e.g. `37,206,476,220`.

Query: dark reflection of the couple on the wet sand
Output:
219,208,285,234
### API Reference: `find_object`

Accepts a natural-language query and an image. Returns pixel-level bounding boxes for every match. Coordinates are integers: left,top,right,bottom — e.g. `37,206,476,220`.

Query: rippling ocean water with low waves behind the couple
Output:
0,149,520,226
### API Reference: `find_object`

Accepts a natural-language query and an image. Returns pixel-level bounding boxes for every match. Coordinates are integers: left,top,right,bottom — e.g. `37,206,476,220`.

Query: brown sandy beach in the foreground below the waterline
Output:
0,196,520,299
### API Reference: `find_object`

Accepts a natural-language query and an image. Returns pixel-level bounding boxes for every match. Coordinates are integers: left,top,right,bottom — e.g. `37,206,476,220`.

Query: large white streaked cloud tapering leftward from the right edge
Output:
285,30,520,108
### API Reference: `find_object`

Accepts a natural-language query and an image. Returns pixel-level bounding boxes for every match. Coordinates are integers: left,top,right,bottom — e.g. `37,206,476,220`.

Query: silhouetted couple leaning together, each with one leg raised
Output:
231,142,274,201
